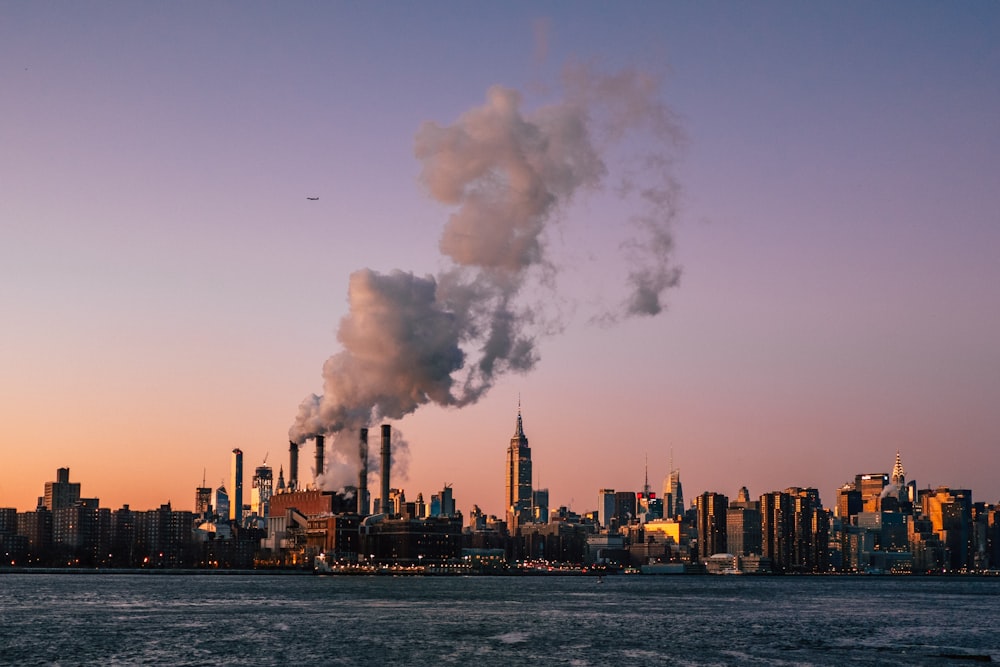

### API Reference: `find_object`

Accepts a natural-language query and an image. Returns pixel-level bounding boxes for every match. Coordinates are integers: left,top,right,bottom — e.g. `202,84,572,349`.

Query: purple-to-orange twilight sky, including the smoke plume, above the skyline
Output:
0,1,1000,516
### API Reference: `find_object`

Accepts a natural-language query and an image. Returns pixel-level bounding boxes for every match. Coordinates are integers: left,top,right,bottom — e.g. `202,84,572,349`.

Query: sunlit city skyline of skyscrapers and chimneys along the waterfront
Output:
0,408,1000,574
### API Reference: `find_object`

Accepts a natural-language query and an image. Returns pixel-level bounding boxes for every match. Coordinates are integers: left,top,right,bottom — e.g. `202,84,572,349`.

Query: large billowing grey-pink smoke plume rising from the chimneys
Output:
289,66,680,488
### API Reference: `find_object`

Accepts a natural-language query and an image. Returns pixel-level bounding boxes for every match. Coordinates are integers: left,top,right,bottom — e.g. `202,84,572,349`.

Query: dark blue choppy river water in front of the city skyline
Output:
0,574,1000,667
